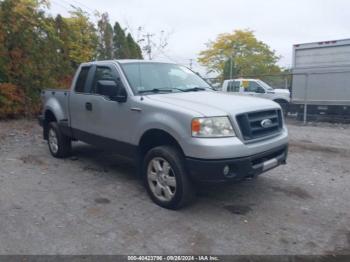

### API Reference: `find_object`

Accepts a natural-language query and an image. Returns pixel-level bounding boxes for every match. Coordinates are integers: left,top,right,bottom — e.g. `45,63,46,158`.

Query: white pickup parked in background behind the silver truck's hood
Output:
222,78,290,112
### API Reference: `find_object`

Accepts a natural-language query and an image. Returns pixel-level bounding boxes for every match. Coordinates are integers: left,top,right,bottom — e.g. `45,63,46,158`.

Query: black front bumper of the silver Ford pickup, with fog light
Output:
186,144,288,182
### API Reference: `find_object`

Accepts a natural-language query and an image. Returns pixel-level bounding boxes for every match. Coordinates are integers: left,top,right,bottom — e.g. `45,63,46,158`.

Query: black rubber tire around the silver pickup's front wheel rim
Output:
142,146,195,210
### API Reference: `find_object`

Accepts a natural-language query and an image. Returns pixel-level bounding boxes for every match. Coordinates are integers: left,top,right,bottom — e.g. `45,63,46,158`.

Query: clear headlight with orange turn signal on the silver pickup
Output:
191,116,236,137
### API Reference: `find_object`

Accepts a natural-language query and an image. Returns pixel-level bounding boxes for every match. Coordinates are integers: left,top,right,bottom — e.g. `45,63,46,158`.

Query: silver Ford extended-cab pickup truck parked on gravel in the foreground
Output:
39,60,288,209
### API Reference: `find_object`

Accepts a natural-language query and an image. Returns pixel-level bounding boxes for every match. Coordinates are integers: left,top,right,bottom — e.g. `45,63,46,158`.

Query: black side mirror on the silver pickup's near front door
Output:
96,80,127,103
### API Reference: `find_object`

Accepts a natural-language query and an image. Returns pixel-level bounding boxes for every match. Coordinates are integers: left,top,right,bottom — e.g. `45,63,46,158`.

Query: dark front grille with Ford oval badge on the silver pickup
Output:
236,109,282,140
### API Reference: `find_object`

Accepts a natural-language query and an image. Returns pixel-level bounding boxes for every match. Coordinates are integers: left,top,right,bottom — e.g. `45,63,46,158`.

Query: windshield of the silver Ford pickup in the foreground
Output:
121,62,211,94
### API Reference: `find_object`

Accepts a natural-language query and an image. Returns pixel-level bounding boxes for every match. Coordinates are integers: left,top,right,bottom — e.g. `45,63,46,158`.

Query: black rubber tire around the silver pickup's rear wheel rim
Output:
47,122,72,158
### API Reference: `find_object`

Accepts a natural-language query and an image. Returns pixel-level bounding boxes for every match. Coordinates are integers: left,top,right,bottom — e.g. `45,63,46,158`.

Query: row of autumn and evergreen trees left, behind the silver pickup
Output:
0,0,142,117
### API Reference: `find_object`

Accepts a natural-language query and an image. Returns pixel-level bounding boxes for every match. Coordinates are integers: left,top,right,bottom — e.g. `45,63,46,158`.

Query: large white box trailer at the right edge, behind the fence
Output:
292,39,350,121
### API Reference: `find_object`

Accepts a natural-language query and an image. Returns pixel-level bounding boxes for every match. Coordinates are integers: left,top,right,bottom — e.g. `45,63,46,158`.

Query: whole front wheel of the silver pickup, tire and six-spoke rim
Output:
143,146,194,209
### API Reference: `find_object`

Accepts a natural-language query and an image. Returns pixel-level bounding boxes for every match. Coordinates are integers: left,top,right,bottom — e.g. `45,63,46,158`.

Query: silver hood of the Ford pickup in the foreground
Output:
148,91,279,116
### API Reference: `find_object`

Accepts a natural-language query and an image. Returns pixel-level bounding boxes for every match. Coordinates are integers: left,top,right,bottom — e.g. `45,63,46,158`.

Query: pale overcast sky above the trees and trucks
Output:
51,0,350,73
